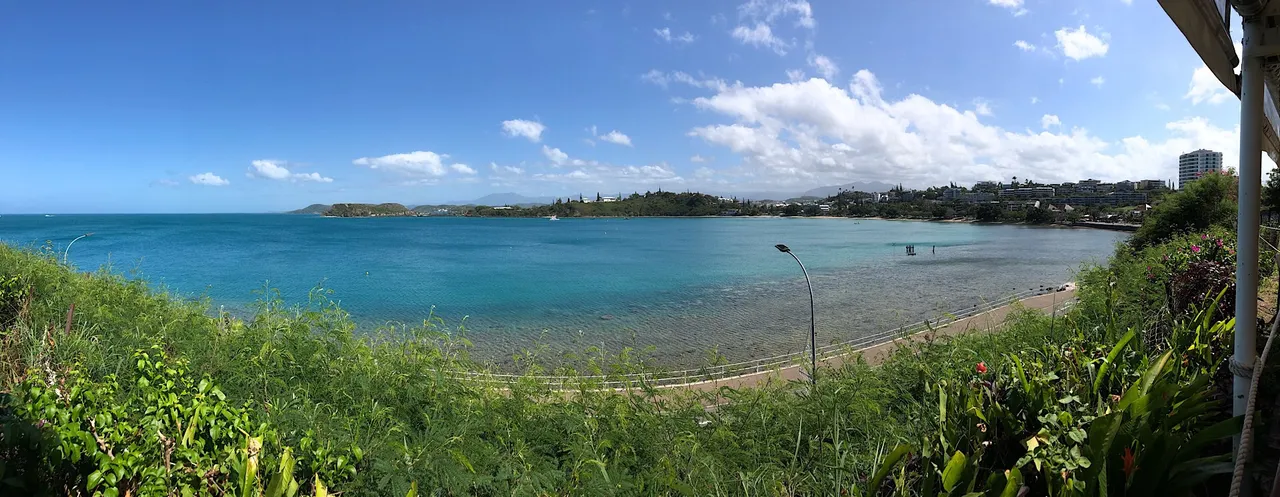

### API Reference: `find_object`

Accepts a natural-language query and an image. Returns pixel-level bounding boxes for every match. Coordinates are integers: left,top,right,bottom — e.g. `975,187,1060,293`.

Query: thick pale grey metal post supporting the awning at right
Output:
1230,17,1266,494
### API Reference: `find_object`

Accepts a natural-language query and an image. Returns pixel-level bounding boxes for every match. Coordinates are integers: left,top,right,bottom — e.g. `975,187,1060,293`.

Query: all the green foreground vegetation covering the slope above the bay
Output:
0,179,1280,497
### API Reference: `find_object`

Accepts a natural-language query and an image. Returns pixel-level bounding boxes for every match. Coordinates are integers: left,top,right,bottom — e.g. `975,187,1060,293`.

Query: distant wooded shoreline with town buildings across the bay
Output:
307,149,1239,229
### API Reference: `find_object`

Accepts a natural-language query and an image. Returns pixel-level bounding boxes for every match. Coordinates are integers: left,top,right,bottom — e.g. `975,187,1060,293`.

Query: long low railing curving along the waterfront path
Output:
451,288,1065,388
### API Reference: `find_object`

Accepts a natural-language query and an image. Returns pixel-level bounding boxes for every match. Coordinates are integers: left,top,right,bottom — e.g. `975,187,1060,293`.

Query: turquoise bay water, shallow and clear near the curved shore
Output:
0,214,1124,365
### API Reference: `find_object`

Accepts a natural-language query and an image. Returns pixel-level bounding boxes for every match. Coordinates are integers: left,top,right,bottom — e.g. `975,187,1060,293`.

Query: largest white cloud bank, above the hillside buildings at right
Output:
689,70,1238,190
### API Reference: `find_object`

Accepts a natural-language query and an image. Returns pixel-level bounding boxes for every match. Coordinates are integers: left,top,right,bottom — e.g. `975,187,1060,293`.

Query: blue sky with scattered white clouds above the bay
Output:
0,0,1271,213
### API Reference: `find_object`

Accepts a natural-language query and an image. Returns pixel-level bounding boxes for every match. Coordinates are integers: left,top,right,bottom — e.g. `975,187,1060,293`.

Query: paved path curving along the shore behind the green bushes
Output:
659,288,1075,392
